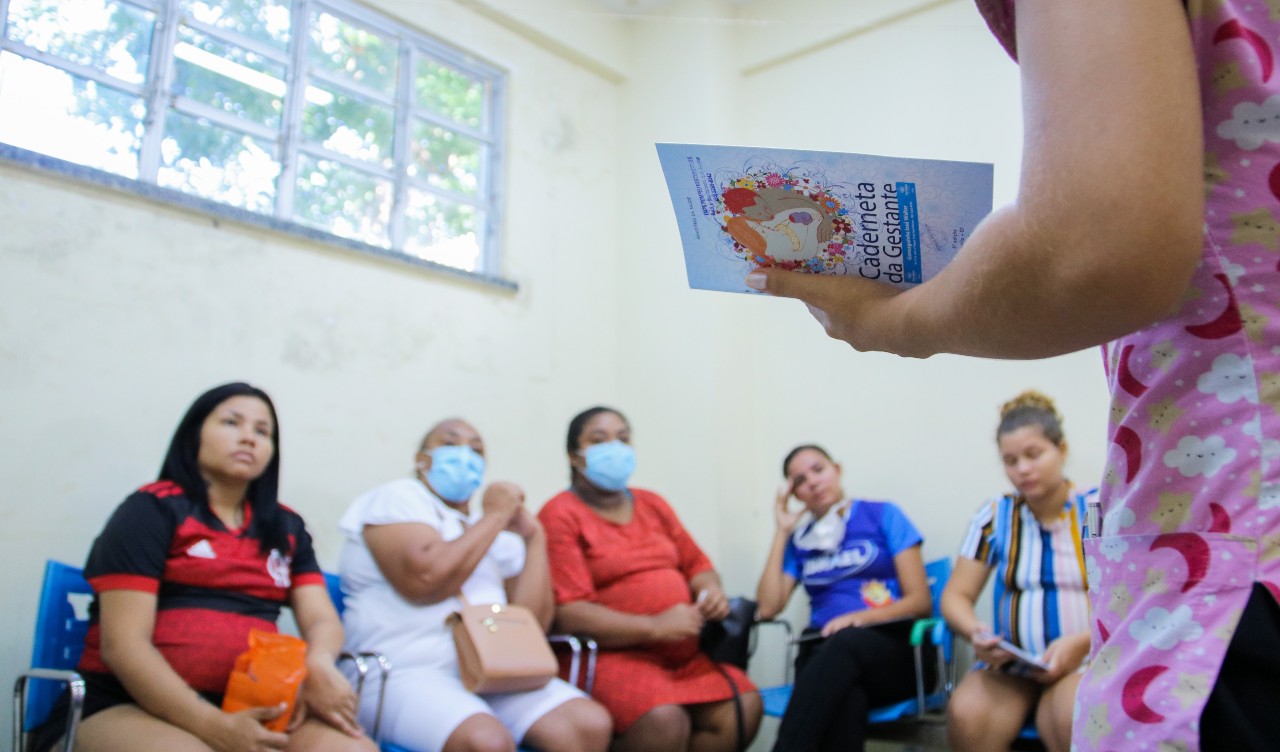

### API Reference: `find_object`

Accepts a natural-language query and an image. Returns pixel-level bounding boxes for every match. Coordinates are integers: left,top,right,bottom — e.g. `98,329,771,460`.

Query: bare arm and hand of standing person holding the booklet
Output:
727,0,1203,358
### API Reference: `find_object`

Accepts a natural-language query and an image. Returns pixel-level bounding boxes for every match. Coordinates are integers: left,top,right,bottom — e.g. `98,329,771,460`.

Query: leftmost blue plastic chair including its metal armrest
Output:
13,559,93,752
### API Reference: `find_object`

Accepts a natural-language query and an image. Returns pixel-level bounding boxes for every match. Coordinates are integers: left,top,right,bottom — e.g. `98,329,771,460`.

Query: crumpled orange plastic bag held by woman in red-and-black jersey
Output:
223,629,307,732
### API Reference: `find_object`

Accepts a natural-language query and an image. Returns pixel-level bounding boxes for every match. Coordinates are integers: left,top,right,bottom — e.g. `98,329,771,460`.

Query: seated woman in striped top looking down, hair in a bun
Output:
942,391,1097,752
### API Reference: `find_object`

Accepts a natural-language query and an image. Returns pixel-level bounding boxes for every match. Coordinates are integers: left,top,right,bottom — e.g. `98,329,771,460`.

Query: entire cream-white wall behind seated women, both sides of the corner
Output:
0,0,1106,746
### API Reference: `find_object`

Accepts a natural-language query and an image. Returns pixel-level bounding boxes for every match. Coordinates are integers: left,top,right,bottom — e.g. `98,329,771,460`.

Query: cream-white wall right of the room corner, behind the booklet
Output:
620,0,1106,616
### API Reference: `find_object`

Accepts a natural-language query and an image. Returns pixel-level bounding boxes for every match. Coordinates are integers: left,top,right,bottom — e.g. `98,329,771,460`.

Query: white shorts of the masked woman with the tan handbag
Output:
360,666,586,752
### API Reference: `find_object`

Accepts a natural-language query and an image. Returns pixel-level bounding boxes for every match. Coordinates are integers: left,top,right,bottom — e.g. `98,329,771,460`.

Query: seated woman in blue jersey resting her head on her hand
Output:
756,444,934,752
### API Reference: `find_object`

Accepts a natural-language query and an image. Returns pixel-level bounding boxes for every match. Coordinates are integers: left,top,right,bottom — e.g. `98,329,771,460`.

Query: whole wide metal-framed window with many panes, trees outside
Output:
0,0,503,275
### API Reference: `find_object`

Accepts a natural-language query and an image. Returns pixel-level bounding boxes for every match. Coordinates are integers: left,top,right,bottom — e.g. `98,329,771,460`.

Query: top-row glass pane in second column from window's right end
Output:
307,13,398,95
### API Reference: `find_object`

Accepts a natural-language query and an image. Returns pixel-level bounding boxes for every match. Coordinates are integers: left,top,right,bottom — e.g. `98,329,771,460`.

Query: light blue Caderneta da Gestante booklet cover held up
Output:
657,143,993,293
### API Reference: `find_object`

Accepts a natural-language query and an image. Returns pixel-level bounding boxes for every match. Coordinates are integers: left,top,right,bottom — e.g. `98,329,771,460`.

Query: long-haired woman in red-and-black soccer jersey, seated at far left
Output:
45,384,376,752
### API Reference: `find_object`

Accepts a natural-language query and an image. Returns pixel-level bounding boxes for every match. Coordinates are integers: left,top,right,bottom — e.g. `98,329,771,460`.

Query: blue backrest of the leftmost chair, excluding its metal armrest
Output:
23,559,93,729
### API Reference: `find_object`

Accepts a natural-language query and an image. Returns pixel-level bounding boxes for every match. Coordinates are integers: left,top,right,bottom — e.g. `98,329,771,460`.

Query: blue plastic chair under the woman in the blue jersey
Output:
760,559,954,725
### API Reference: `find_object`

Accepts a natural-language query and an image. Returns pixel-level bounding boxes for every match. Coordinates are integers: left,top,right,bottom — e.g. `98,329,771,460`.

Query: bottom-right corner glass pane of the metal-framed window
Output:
404,191,483,271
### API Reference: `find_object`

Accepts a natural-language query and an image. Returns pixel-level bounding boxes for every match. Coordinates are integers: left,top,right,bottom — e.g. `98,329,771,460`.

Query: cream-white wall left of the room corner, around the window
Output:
0,4,623,737
